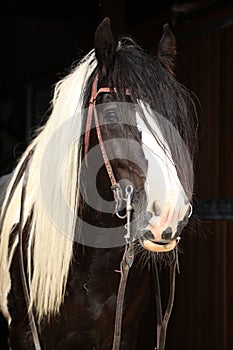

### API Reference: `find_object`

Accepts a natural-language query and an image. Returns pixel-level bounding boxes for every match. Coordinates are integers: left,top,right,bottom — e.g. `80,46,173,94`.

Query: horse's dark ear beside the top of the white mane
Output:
94,17,116,76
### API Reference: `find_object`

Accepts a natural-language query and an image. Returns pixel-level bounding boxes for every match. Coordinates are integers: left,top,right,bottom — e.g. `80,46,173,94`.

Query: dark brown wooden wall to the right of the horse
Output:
166,7,233,350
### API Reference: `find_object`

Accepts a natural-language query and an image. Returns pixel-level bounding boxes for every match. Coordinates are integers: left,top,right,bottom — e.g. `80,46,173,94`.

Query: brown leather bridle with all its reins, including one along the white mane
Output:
15,75,178,350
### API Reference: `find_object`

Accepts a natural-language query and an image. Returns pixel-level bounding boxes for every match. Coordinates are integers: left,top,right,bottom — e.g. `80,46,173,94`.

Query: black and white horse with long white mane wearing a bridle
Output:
0,17,196,350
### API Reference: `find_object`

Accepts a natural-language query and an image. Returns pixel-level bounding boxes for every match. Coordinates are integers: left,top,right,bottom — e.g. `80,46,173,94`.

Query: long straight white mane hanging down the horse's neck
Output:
0,50,97,321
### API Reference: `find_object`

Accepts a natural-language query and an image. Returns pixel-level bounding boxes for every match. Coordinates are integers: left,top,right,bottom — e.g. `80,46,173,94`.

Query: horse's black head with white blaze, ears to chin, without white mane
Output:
79,18,192,252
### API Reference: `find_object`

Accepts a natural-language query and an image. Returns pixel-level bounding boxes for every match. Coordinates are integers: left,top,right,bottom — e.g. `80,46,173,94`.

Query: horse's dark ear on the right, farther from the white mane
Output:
158,23,176,74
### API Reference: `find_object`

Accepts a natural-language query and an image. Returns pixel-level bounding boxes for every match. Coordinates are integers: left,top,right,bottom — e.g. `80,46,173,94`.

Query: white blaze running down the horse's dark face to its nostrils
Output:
136,105,189,240
